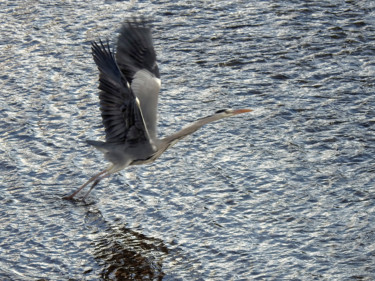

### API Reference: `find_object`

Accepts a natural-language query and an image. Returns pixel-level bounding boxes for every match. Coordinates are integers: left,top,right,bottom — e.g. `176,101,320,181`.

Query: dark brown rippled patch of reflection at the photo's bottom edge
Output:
94,227,168,280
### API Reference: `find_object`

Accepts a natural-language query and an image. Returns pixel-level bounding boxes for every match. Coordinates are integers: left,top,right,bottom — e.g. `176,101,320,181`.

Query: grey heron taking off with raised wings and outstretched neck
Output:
63,18,252,200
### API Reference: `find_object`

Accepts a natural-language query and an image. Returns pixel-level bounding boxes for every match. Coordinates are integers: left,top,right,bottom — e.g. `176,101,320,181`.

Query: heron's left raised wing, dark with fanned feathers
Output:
91,41,149,144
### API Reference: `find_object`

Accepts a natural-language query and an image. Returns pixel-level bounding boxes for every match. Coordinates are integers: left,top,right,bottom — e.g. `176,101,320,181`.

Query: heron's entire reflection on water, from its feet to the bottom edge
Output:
64,200,170,281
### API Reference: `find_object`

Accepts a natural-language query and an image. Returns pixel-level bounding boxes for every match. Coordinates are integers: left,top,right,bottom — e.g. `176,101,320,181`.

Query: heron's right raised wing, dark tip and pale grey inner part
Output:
116,18,161,139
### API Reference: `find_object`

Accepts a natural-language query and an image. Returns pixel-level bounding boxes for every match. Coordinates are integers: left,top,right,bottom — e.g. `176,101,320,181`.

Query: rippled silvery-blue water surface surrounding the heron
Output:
0,0,375,280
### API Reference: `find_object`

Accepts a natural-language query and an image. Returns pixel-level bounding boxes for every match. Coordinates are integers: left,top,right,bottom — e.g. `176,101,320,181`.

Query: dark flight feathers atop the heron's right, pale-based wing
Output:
116,18,160,80
